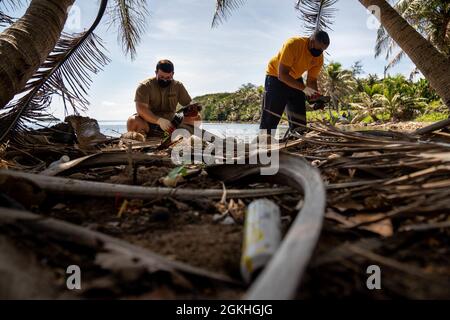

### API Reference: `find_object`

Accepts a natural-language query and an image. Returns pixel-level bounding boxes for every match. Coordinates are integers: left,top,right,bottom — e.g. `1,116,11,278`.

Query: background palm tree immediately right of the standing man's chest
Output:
319,62,357,113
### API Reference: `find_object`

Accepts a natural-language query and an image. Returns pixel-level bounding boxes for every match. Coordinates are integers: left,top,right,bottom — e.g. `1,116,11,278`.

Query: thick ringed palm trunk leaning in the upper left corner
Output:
0,0,75,109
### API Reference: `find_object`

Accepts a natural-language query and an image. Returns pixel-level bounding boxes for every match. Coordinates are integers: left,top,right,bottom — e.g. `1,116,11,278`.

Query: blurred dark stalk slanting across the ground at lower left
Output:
0,208,240,285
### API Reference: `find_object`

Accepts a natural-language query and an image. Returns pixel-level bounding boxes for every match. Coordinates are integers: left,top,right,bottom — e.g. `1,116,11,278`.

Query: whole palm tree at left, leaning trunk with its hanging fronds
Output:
0,0,148,141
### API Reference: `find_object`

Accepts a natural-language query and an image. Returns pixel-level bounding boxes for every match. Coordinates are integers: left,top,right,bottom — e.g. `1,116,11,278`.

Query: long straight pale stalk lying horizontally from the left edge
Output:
0,170,293,200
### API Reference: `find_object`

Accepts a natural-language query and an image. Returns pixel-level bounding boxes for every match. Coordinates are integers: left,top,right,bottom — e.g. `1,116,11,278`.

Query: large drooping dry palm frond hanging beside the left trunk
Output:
0,0,109,141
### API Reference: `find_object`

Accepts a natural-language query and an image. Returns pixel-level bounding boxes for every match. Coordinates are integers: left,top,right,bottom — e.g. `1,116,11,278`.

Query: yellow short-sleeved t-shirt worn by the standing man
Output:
267,37,323,79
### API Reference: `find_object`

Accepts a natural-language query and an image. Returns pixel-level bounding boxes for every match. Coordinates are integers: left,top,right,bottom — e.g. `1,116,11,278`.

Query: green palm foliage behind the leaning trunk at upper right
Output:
375,0,450,71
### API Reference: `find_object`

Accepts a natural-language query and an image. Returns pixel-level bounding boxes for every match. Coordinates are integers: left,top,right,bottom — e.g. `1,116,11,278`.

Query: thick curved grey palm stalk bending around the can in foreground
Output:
208,153,325,300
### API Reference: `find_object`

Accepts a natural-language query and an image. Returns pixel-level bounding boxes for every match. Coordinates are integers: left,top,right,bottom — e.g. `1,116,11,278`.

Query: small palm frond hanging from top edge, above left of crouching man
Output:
108,0,149,60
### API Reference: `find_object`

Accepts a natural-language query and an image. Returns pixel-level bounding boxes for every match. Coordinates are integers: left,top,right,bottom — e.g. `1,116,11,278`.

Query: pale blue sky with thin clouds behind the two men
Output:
4,0,413,120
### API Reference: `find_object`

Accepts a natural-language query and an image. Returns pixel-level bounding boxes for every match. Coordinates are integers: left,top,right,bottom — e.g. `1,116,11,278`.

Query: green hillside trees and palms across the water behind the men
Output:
194,62,449,123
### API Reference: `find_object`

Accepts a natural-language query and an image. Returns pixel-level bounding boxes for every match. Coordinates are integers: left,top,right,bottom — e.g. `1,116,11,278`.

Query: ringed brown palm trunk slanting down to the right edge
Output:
359,0,450,108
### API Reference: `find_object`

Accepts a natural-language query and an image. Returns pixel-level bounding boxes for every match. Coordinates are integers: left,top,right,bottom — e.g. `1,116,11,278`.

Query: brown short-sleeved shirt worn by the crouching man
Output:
134,78,192,120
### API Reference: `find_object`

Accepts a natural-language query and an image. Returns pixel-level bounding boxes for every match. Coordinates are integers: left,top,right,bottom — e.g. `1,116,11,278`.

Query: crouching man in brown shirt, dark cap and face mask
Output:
127,60,201,136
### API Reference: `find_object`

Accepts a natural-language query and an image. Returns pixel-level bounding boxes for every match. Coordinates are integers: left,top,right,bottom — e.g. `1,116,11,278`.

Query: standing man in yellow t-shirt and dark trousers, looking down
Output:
260,31,330,131
